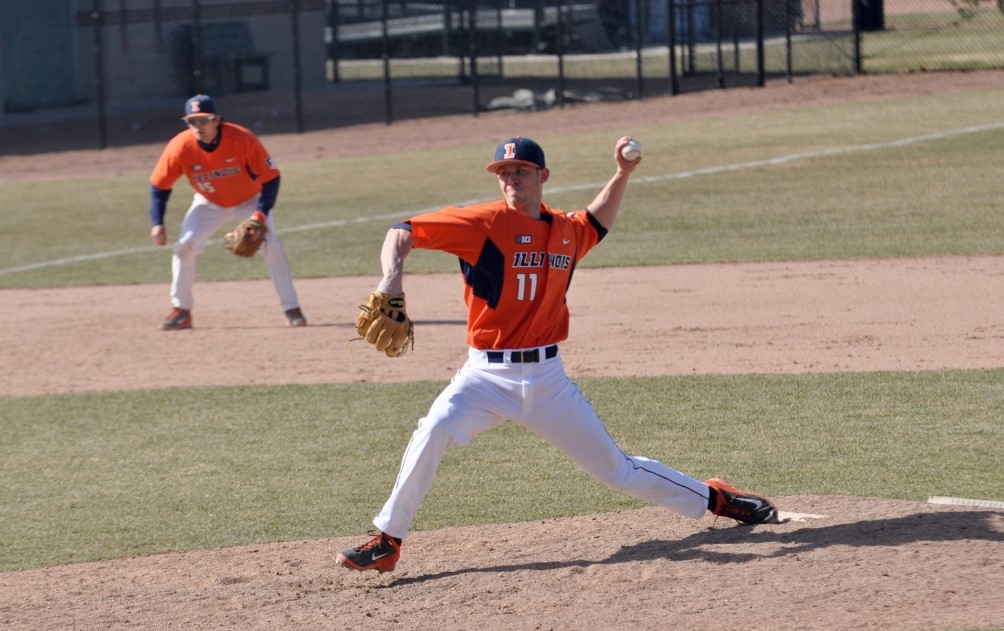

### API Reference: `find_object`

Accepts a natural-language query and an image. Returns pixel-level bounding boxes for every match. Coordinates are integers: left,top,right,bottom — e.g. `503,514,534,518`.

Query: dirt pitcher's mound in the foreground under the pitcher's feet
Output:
7,496,1004,631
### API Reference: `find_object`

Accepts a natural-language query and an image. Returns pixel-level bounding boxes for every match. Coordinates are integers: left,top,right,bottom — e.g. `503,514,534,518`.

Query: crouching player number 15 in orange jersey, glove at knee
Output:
150,94,307,331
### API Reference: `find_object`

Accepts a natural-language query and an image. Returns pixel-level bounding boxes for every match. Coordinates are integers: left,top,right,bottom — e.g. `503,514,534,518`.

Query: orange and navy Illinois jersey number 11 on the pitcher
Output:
409,200,606,350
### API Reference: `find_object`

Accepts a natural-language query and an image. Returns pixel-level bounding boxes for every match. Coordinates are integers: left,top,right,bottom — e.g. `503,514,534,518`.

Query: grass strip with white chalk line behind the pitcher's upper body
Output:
0,82,1004,287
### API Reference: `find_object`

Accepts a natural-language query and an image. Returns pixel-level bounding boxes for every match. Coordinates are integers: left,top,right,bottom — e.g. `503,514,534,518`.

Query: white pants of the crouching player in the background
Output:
171,193,300,310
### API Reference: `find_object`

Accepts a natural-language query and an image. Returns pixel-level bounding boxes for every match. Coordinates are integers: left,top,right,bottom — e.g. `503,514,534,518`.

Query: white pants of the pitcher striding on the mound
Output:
373,348,710,539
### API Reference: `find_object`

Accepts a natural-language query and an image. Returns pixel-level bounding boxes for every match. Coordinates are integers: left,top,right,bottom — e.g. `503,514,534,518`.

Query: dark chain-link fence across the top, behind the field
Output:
0,0,1004,154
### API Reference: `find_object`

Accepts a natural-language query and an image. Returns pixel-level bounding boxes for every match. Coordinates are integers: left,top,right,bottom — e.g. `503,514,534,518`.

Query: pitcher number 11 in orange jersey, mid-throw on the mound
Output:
336,137,777,572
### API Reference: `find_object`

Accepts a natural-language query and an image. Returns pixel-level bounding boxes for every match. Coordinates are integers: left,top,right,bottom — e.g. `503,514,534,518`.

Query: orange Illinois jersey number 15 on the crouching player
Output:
150,123,279,208
